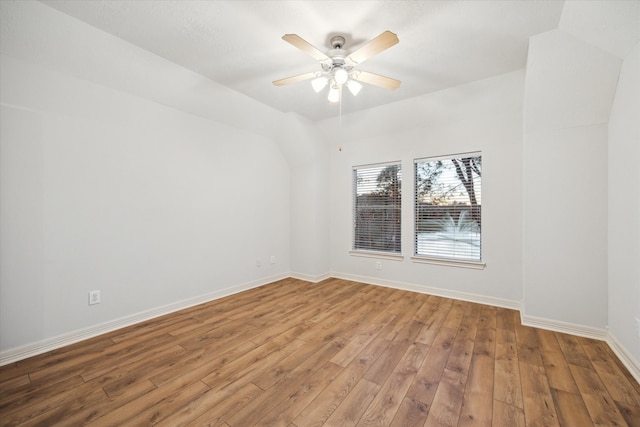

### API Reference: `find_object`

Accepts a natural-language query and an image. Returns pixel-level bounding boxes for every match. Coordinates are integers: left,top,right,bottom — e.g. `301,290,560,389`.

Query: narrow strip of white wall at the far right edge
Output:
608,44,640,369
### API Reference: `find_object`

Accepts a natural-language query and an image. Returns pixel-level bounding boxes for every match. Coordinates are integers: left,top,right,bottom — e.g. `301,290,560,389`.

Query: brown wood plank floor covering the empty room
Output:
0,279,640,427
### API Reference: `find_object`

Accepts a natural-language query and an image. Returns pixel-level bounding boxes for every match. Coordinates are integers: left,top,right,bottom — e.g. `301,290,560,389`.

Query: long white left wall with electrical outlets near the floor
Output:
0,55,289,352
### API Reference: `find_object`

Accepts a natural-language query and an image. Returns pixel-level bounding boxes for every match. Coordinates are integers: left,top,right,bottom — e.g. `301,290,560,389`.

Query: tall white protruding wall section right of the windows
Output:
523,30,621,331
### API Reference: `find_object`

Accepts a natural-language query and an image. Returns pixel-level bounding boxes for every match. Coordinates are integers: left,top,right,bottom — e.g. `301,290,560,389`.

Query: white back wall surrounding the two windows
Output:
321,71,524,306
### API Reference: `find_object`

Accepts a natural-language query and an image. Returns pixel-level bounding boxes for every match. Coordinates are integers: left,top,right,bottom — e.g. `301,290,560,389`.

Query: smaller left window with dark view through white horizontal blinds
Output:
353,162,402,254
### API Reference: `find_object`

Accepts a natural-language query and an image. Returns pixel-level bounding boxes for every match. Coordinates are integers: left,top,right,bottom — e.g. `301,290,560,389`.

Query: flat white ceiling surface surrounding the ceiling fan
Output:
31,0,636,121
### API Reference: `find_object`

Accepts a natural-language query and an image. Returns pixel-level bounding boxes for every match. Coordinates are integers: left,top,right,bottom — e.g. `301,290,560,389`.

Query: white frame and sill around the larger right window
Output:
411,151,486,269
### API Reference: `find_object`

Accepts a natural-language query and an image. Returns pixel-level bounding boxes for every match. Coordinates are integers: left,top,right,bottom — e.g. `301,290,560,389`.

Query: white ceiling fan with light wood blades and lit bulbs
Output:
273,31,400,102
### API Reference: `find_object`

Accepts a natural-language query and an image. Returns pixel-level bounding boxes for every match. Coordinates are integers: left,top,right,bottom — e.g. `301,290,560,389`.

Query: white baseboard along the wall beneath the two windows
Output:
331,271,522,311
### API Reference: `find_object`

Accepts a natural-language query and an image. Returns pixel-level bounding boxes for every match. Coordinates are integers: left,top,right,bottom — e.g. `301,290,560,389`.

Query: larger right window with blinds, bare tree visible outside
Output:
414,153,482,263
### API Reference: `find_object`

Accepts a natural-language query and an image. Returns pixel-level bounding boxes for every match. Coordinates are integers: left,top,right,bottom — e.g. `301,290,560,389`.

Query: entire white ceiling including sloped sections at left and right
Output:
0,0,640,123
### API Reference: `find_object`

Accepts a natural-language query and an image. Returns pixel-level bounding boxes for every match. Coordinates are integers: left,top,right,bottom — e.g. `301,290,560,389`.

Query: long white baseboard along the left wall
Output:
0,273,290,366
